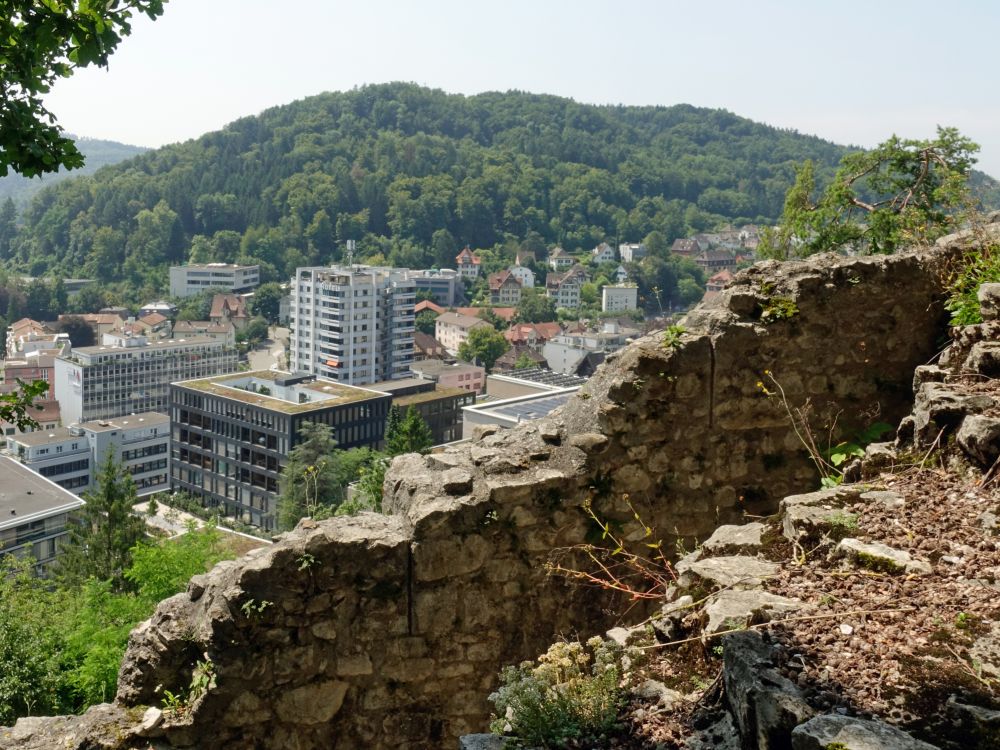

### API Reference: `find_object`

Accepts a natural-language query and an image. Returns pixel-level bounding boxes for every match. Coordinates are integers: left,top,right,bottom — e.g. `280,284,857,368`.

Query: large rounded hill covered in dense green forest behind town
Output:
0,83,984,288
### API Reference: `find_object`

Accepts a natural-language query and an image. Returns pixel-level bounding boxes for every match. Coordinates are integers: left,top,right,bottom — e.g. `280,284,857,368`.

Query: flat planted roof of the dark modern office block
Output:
171,370,389,414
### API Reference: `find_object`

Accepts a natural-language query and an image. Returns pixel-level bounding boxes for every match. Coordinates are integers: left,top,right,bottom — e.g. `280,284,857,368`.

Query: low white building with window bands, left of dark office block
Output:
7,412,170,495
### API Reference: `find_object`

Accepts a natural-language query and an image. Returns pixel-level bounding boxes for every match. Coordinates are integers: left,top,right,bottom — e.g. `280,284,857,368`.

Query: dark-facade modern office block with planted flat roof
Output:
170,370,392,529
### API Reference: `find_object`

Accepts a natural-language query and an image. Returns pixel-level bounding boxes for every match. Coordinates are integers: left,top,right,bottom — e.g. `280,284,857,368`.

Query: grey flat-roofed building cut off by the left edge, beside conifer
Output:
0,456,84,574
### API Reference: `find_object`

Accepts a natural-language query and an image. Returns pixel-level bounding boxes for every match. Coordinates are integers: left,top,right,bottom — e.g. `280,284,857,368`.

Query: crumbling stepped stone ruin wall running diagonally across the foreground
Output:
0,232,984,750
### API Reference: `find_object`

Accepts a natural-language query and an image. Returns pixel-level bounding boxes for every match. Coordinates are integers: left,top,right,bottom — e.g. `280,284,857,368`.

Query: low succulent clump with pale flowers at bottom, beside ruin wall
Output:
489,637,628,747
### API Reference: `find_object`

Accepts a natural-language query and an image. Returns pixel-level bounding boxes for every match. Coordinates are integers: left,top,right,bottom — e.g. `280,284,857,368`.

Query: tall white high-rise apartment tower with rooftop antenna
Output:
289,266,416,385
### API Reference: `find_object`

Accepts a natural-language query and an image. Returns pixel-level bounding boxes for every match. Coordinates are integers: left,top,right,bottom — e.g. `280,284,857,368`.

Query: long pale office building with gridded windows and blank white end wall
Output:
55,334,237,424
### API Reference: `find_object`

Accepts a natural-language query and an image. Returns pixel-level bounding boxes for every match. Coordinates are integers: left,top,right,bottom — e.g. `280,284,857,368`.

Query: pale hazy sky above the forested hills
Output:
47,0,1000,178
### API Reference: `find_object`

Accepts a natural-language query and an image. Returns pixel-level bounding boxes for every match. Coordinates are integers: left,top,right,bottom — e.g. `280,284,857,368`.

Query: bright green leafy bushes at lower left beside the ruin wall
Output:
0,525,225,726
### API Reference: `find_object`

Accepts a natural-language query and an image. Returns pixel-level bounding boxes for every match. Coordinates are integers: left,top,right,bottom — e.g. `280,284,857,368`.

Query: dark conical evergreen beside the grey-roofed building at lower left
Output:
57,451,146,591
